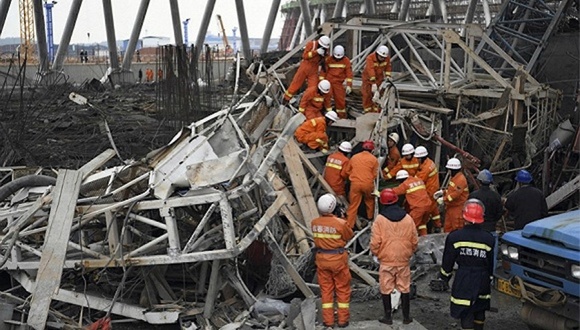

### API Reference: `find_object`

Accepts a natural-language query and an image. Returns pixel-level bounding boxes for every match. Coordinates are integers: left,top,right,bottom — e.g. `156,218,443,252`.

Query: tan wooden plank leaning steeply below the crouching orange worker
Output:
283,140,319,230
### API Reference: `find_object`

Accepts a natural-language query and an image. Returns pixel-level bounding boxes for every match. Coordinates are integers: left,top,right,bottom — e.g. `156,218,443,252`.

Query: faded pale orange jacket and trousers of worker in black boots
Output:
370,210,418,294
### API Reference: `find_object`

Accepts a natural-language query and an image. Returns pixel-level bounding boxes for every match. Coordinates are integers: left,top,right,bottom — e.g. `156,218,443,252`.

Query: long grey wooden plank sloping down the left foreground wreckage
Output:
28,170,83,329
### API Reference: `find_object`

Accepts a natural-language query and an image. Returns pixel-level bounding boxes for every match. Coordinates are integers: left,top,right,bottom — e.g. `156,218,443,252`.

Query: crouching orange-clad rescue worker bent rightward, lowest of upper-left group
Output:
294,111,338,153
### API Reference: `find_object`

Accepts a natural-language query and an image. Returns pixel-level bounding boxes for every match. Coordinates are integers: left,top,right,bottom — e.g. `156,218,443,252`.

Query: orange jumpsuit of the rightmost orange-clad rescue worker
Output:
443,172,469,233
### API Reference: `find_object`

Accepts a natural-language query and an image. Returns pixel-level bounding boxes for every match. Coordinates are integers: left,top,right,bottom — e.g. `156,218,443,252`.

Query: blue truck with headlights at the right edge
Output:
494,210,580,330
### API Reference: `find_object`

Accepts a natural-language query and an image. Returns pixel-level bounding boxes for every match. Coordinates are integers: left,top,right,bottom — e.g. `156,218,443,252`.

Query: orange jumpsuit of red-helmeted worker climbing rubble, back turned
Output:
346,150,379,228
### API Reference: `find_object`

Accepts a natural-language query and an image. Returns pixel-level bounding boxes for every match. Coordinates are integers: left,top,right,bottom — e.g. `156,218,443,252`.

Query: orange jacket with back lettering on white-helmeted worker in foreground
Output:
311,215,353,266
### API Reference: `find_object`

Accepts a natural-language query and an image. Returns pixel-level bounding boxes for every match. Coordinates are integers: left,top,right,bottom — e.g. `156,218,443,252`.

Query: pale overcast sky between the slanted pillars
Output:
0,0,287,44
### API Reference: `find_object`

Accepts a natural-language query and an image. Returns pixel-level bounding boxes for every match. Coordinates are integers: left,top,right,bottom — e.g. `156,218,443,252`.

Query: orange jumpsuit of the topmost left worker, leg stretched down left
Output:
284,40,323,101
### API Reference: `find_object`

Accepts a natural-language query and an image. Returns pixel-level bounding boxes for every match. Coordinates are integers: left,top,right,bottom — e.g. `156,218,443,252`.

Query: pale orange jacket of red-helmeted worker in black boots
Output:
370,214,418,266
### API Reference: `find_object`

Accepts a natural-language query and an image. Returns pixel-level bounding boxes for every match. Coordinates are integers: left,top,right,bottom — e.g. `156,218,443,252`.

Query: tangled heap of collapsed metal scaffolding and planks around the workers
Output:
0,14,578,329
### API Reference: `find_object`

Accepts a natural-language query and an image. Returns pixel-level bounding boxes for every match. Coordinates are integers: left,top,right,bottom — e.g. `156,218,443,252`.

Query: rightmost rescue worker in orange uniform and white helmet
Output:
433,158,469,233
